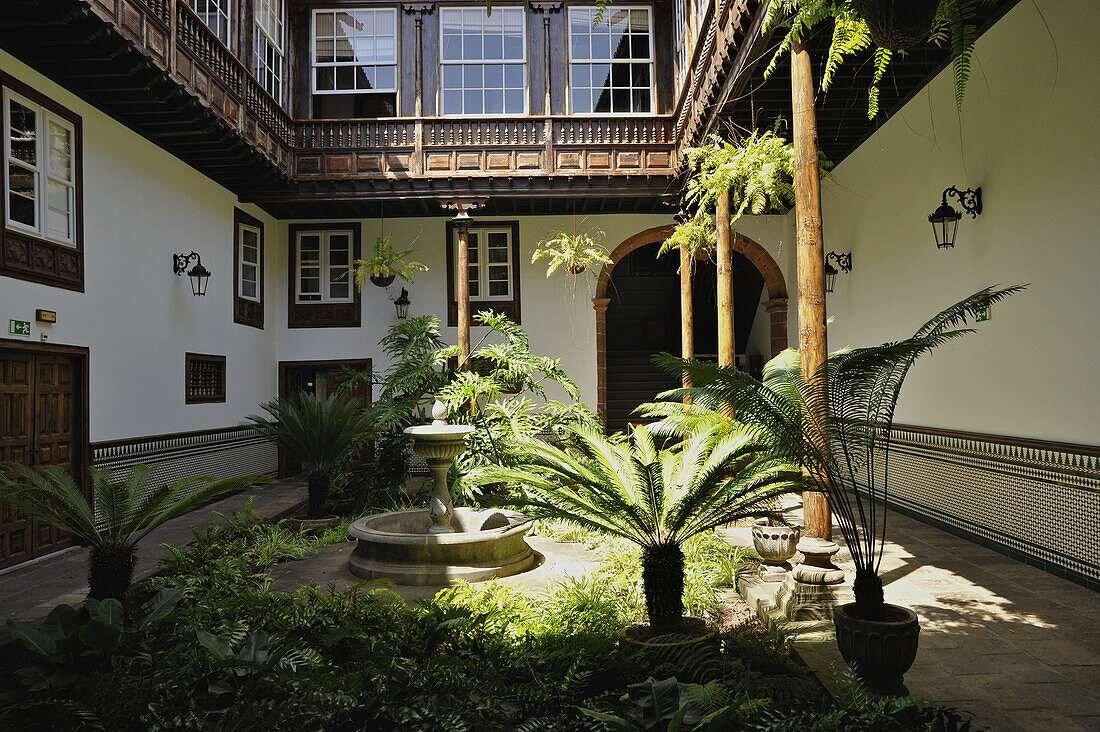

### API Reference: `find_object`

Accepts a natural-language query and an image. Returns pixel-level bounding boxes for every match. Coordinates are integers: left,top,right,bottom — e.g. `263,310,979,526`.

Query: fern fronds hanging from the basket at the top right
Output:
763,0,998,119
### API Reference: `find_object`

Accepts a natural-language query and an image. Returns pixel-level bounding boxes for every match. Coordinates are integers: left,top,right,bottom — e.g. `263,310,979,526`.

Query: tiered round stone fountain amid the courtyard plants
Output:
348,400,539,584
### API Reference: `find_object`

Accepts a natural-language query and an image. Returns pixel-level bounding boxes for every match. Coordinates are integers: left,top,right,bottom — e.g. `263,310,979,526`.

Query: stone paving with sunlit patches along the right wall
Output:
727,512,1100,732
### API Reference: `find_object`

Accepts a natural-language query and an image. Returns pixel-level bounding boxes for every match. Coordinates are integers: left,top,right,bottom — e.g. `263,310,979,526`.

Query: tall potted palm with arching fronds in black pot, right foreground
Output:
642,286,1021,693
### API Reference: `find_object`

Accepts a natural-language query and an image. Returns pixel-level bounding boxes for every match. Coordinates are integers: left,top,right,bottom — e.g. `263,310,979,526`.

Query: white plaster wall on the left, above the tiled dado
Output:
0,52,285,441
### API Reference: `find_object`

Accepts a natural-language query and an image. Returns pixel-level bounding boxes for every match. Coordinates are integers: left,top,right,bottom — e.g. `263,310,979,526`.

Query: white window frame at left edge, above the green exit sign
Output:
0,87,80,249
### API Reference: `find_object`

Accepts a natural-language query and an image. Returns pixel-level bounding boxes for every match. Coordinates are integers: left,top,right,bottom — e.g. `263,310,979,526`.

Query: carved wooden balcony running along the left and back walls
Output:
0,0,675,216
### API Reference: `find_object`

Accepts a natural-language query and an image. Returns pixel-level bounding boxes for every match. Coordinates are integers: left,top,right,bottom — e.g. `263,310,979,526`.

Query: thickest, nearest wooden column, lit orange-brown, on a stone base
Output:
791,43,833,539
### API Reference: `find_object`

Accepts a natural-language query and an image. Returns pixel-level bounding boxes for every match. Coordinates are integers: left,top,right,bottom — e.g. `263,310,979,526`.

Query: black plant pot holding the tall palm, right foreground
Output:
833,602,921,696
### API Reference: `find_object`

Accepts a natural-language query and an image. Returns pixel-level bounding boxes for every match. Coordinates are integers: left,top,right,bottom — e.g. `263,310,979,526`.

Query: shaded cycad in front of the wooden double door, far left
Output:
0,462,271,600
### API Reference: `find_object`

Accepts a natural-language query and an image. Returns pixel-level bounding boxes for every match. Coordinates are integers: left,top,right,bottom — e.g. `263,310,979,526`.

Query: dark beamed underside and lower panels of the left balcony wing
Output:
0,0,289,192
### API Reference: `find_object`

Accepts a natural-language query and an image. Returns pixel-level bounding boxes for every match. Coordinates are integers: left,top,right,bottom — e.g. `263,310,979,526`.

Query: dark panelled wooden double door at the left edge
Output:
0,340,90,568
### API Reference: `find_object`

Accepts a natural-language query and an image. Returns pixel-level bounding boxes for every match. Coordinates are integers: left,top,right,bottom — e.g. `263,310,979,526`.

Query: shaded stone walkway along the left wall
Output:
0,481,306,643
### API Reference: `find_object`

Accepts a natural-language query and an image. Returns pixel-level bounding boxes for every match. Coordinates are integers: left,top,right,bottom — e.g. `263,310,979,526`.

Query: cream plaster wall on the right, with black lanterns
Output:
822,0,1100,445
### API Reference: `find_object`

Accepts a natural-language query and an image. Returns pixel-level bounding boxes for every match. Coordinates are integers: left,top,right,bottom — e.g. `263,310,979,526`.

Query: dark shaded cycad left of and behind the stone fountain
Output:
249,391,371,518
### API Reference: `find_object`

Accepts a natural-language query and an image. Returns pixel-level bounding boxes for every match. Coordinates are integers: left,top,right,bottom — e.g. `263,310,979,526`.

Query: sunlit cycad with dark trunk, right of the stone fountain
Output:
473,426,803,634
